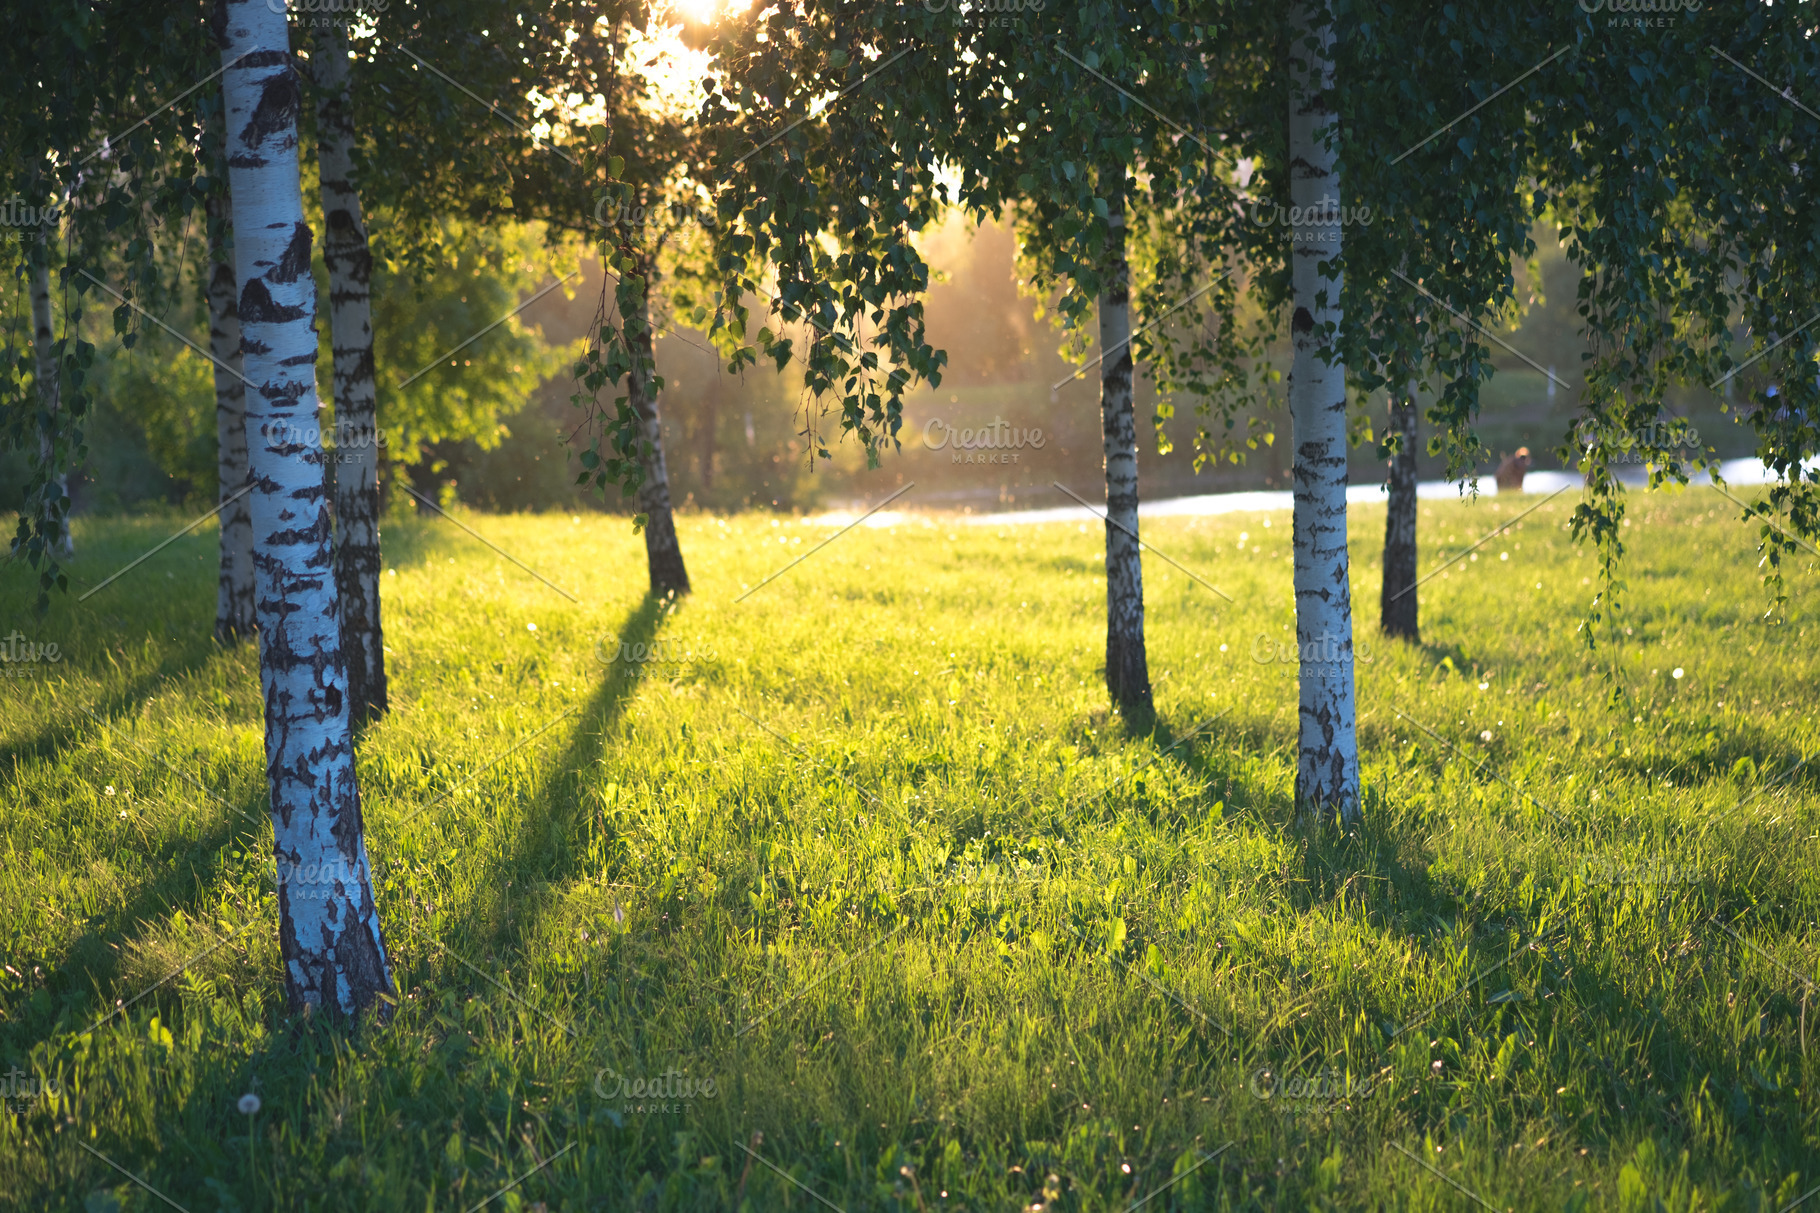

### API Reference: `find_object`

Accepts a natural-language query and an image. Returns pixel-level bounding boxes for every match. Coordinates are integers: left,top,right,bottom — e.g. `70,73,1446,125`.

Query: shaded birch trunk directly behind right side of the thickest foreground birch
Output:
313,24,386,723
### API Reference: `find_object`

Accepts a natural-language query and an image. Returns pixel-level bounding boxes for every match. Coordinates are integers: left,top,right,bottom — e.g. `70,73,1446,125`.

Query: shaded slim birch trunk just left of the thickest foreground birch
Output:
209,195,257,641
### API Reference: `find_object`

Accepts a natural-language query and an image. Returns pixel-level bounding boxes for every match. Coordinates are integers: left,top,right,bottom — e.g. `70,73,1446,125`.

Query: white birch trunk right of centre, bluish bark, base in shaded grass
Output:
1289,0,1360,825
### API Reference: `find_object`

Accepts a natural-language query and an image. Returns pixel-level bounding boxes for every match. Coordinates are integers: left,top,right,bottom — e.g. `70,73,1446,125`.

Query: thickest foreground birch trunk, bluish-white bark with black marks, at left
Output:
215,0,391,1018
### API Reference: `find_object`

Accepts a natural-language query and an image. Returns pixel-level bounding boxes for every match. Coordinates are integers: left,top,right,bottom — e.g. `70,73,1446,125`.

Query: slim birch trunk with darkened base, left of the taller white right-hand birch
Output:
1099,174,1152,718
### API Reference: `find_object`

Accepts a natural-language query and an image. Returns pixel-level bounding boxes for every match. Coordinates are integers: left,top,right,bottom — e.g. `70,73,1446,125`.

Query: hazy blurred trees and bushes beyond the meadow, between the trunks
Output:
0,214,1753,514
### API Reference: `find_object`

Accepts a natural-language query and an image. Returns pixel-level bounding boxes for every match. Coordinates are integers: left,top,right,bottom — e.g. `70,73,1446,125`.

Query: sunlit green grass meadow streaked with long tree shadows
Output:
0,490,1820,1213
